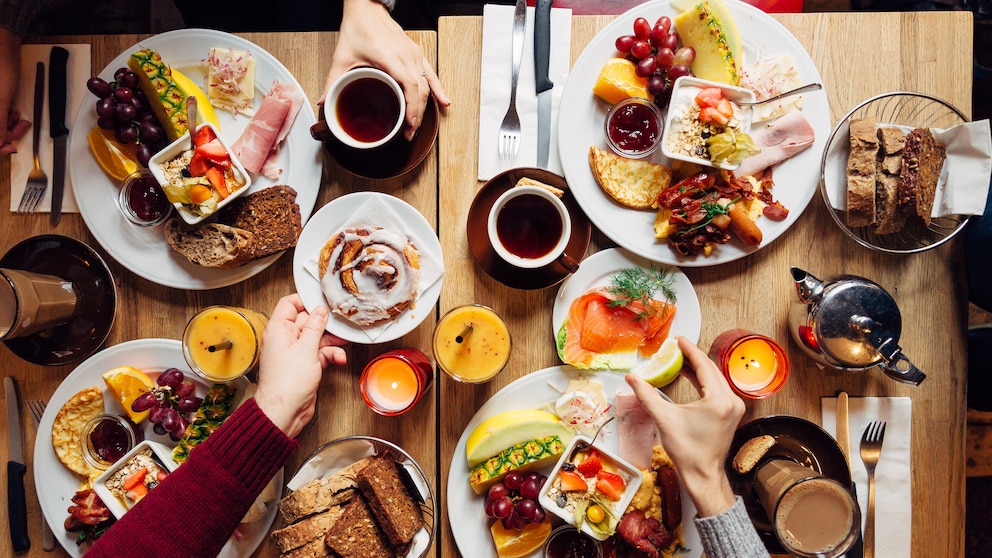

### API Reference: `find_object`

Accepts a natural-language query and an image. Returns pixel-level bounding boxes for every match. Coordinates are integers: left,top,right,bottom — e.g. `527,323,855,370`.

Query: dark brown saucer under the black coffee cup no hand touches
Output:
467,167,592,290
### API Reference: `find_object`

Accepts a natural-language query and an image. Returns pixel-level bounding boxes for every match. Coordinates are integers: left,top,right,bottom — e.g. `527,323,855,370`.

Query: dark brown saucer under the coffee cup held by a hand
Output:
318,95,440,180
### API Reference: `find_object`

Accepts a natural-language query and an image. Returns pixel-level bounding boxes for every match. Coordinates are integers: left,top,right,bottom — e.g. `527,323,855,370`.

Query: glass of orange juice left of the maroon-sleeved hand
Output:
183,306,269,382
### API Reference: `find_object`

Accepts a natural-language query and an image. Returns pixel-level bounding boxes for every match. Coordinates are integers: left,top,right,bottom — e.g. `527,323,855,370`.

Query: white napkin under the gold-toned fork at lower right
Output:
820,397,913,558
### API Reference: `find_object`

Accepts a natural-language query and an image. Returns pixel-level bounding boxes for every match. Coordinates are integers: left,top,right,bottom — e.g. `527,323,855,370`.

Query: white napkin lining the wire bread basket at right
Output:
824,120,992,217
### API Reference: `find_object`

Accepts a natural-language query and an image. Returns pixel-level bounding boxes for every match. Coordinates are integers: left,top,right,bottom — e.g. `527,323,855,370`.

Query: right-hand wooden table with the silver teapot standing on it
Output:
438,8,972,557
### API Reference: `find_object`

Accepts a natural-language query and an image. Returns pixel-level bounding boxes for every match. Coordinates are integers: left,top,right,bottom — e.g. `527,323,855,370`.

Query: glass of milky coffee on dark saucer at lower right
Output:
753,459,861,558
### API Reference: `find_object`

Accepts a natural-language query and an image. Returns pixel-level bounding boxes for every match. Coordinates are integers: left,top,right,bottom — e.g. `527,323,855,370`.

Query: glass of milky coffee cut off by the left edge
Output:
0,269,77,340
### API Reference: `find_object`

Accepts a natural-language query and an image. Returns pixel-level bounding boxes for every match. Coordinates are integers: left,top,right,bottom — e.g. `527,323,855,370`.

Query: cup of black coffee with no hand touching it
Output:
488,186,579,273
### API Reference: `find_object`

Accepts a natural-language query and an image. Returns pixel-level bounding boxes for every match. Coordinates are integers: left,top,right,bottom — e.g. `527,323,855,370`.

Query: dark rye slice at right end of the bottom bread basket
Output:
356,456,424,547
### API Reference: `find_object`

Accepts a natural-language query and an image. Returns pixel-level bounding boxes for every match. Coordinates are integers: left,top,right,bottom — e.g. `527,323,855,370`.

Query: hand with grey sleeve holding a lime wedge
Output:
626,336,744,517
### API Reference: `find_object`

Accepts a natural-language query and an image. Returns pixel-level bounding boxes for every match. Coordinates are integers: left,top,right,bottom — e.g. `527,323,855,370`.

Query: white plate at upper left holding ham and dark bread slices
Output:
69,29,322,290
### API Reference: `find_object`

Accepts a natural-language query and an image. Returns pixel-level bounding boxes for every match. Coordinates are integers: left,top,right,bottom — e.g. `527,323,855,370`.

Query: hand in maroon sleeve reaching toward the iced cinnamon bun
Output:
255,294,347,438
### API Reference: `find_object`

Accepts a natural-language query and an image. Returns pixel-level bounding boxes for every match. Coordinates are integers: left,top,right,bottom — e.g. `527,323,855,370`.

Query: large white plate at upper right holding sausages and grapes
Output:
558,0,830,267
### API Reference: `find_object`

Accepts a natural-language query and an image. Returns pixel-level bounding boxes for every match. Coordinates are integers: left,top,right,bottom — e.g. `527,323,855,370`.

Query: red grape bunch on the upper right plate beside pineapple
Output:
616,16,696,108
